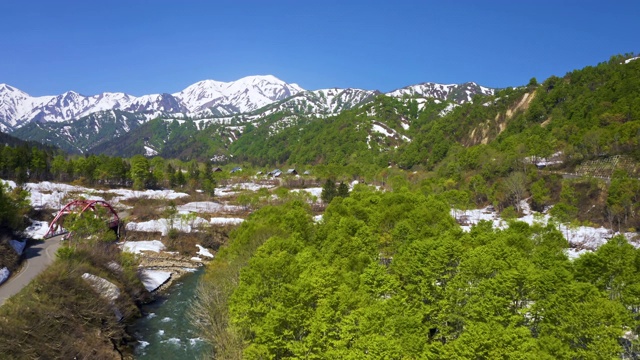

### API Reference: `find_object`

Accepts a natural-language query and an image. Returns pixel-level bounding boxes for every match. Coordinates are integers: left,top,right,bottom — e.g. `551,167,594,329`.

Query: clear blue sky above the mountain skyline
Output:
0,0,640,96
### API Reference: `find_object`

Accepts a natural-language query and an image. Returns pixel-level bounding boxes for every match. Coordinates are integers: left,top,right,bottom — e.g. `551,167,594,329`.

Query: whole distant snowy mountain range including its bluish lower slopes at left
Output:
0,75,494,153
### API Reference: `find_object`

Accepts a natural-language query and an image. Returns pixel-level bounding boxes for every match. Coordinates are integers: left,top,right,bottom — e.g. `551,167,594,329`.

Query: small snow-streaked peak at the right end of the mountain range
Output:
385,82,494,104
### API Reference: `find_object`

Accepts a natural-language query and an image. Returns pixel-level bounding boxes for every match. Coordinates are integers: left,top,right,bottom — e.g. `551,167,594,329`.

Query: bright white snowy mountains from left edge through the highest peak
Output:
0,75,304,131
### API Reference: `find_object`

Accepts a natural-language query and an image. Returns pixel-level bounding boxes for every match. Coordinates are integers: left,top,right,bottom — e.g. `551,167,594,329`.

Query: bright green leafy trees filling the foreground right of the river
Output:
194,187,640,359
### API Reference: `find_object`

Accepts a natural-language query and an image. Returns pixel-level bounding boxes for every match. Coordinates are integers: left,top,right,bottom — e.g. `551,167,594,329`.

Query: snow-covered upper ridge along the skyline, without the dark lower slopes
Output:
0,75,493,132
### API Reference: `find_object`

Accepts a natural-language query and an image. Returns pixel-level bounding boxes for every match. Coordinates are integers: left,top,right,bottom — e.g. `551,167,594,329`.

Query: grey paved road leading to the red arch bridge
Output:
0,236,62,306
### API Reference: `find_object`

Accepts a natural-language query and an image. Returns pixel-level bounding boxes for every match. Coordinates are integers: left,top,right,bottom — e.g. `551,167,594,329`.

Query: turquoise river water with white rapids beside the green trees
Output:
132,268,206,360
